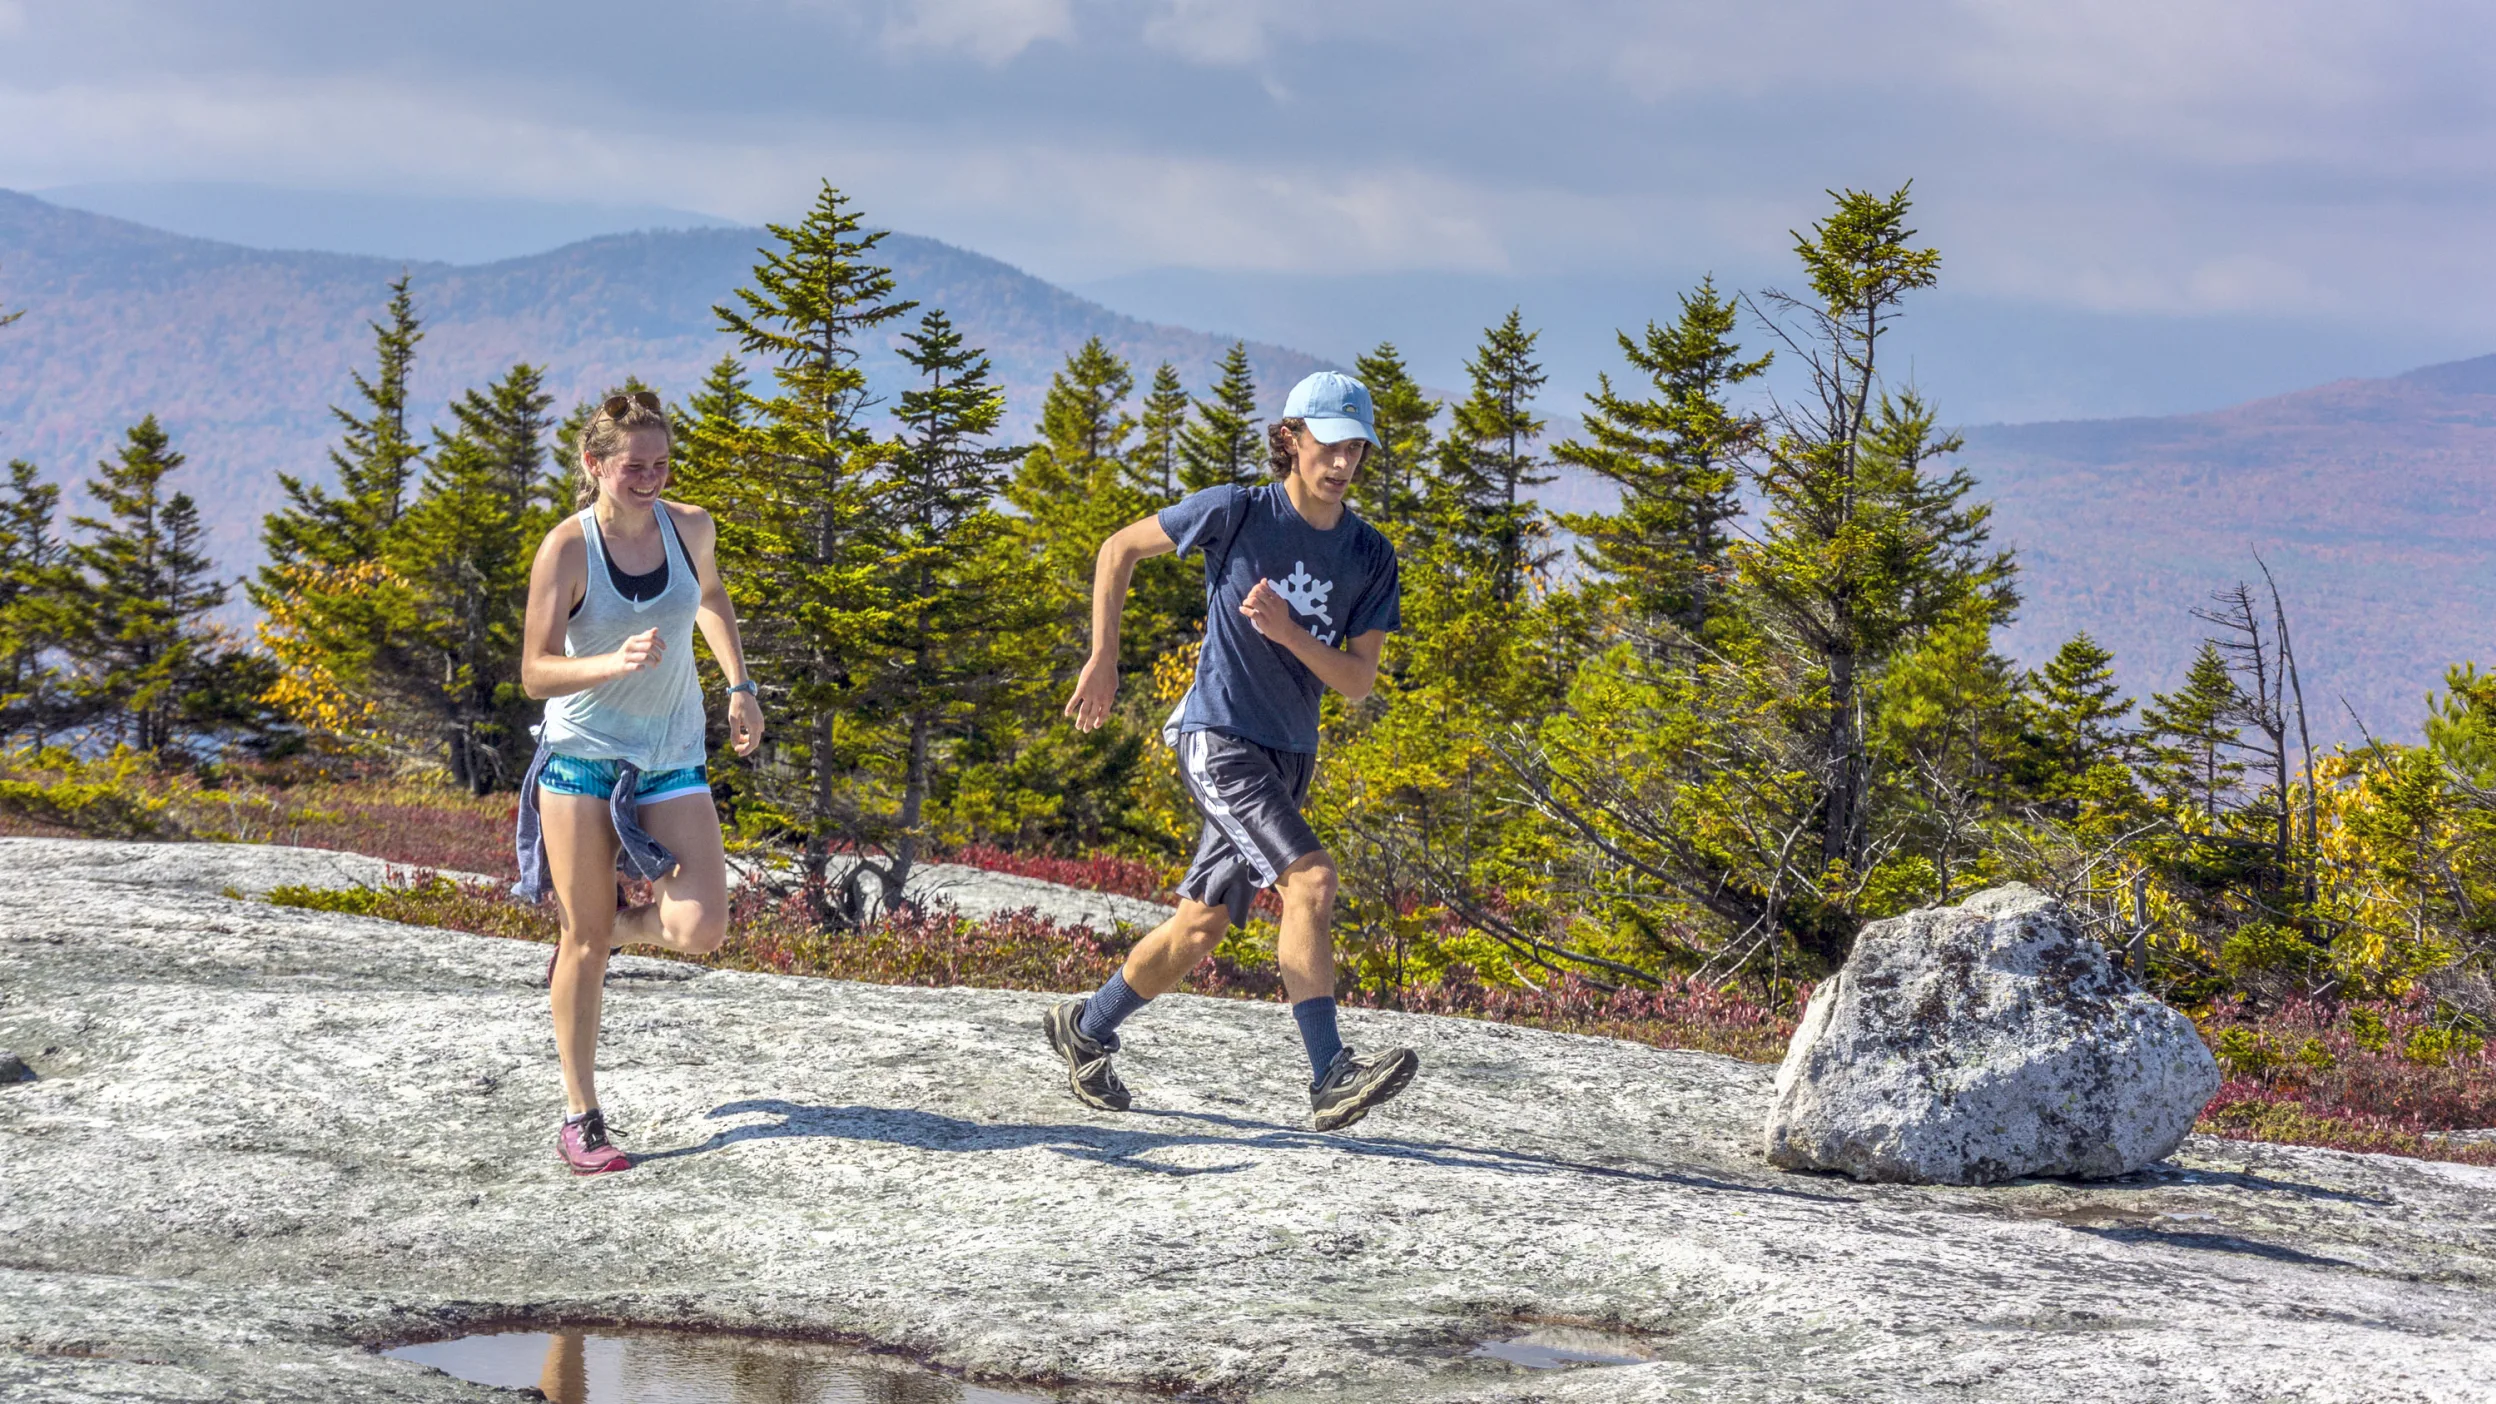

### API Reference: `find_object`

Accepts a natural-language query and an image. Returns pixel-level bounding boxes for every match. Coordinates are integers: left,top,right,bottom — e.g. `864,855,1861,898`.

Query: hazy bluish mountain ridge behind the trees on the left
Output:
0,190,1320,572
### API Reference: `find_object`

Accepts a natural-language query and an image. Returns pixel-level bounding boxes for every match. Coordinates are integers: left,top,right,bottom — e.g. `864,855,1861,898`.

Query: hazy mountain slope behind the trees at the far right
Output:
1964,357,2496,739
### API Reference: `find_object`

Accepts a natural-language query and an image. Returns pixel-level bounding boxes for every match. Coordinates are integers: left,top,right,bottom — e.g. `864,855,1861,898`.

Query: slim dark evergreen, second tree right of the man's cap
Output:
1433,307,1550,607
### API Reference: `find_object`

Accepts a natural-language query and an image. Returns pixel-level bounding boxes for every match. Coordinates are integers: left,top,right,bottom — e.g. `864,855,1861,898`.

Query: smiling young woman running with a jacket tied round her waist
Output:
519,390,764,1174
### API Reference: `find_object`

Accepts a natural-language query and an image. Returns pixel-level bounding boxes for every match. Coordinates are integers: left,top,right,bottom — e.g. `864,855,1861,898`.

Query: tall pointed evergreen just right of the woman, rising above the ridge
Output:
716,182,916,899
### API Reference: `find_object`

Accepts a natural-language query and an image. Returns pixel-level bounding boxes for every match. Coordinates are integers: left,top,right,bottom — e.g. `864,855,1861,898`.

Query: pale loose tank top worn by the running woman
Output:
537,502,706,772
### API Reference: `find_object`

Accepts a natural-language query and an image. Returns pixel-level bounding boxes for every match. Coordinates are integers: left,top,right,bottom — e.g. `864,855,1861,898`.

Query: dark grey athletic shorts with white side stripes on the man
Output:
1178,732,1325,927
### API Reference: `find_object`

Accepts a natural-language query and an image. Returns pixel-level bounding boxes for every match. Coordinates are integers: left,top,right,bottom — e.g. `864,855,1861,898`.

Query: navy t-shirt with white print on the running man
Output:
1161,482,1403,754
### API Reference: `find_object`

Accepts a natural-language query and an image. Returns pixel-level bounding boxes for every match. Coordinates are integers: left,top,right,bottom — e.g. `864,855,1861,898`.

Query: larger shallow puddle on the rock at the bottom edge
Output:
382,1332,1048,1404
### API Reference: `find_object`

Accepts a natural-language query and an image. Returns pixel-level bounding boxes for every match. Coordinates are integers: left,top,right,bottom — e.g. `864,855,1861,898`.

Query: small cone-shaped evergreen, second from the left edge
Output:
62,415,247,757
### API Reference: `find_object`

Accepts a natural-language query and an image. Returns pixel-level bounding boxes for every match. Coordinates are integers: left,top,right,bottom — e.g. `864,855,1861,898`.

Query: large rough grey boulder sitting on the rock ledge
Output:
1767,884,2219,1184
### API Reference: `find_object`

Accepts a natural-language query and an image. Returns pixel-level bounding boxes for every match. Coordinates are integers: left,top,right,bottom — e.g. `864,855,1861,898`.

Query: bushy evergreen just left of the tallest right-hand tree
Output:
1553,280,1770,640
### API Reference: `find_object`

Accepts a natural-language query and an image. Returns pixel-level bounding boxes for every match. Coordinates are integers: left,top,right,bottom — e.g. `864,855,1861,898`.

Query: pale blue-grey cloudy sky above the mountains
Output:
0,0,2496,409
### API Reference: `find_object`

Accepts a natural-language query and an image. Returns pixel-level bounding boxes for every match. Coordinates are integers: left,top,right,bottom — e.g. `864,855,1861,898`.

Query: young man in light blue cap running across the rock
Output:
1046,372,1420,1132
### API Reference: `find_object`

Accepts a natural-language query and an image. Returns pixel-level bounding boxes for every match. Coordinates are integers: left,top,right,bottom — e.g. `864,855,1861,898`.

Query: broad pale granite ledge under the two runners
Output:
0,839,2496,1404
